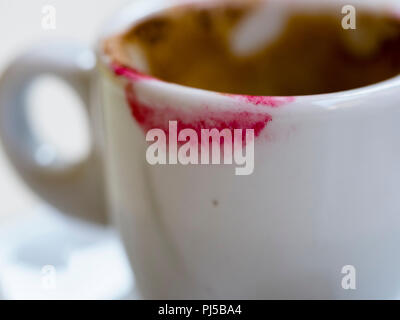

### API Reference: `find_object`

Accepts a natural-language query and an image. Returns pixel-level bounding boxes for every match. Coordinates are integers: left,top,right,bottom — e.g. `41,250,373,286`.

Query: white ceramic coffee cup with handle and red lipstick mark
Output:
0,0,400,299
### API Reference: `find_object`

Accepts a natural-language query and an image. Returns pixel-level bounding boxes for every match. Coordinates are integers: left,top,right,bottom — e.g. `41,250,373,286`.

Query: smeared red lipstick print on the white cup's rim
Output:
111,63,295,140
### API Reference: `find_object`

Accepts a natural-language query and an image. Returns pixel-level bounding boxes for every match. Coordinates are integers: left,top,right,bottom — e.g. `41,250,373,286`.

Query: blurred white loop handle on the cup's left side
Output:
0,42,107,223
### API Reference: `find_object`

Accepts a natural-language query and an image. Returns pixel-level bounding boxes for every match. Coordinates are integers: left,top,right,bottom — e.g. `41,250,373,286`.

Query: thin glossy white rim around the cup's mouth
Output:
96,0,400,109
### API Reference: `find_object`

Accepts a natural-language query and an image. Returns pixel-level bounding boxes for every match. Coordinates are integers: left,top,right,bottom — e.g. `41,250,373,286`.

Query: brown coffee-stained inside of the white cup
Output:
105,4,400,96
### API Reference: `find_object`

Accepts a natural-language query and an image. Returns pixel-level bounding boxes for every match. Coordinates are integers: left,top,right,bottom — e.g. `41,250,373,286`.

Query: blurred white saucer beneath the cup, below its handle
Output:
0,206,138,300
